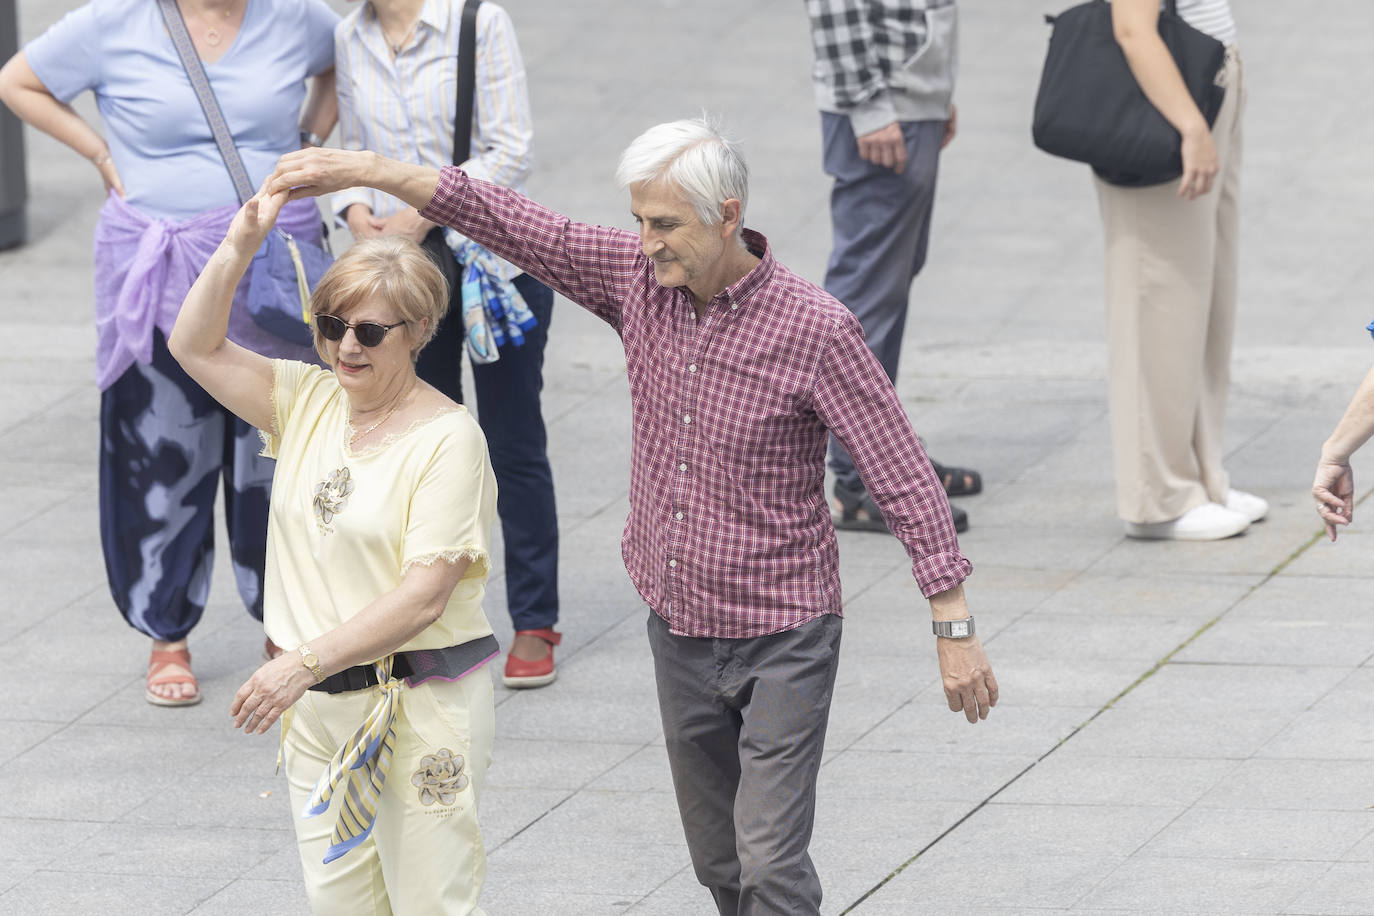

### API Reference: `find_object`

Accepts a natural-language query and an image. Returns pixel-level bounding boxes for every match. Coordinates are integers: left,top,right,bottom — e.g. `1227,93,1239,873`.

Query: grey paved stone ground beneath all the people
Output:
0,0,1374,916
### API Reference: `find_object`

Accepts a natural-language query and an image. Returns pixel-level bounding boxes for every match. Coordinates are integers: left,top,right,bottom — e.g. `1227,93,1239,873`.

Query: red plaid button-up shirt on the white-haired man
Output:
422,166,973,639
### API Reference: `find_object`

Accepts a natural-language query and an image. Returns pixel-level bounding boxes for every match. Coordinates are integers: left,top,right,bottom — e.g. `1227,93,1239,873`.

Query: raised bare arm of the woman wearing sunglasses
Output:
168,190,286,430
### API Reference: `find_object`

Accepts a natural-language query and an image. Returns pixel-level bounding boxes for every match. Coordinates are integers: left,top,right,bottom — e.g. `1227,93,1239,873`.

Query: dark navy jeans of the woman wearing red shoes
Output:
415,229,558,630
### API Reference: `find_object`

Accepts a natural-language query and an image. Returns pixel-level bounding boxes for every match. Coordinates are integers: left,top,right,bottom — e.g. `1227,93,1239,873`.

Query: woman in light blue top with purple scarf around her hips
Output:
0,0,338,706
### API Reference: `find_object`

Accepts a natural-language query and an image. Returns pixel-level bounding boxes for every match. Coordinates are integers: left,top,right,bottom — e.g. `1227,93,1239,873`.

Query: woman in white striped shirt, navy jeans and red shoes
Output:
333,0,561,688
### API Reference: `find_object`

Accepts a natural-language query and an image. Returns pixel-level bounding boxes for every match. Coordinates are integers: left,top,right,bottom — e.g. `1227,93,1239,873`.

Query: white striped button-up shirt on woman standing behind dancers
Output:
333,0,534,217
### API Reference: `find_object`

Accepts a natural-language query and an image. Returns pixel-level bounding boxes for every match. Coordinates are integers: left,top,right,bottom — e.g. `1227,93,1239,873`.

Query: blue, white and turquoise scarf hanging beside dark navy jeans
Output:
444,228,539,364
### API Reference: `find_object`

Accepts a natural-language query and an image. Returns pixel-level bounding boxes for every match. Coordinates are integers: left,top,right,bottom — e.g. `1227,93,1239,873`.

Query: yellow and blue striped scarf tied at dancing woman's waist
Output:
301,655,403,865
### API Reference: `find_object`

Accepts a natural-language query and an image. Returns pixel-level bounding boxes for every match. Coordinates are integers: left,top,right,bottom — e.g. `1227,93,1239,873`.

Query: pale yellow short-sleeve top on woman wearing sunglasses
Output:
262,360,496,651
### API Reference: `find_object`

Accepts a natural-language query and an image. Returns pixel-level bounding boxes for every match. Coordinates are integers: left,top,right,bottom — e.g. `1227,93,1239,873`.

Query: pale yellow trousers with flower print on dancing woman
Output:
283,667,496,916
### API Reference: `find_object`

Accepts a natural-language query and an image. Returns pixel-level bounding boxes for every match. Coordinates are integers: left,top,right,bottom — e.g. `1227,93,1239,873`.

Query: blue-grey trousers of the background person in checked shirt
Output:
820,111,945,489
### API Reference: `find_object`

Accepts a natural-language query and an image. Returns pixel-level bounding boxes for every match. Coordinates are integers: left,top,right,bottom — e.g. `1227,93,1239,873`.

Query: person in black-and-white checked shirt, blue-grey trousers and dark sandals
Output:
807,0,982,531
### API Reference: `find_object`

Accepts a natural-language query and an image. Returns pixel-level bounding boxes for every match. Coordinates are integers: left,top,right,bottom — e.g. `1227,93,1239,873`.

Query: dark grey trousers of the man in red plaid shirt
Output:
649,612,841,916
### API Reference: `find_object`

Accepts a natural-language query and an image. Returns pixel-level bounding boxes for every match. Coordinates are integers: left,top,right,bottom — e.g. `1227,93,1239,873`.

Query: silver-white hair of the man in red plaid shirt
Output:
616,118,749,225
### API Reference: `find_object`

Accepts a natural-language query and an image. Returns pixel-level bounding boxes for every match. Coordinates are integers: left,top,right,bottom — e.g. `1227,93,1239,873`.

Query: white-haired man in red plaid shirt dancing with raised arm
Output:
271,121,998,916
